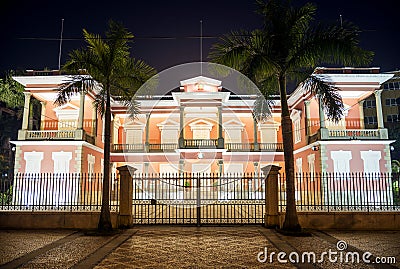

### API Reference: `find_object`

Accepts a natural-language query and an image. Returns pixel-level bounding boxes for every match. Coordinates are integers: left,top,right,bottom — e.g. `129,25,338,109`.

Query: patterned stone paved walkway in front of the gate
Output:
0,226,400,269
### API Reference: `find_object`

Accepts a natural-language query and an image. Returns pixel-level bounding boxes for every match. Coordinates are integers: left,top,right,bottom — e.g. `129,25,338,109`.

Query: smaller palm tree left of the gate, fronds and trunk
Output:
56,21,155,231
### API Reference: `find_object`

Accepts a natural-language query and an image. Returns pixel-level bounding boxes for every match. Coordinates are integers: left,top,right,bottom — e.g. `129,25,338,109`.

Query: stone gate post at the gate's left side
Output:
117,165,136,228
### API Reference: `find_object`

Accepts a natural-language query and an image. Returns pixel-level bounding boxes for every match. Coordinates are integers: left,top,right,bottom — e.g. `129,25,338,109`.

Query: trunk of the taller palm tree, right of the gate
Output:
279,75,301,232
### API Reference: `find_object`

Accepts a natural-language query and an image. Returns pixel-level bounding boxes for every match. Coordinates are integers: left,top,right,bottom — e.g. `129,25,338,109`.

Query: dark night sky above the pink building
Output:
0,0,400,77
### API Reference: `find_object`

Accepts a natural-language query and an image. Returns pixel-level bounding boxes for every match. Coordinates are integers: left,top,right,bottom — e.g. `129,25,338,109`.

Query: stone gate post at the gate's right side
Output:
261,165,282,228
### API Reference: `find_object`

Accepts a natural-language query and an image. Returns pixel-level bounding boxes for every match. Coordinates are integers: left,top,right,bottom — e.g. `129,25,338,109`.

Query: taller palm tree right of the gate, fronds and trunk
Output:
209,0,373,232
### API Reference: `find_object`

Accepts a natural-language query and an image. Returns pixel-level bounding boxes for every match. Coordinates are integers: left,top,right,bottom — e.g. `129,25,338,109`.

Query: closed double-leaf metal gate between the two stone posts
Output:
132,174,265,226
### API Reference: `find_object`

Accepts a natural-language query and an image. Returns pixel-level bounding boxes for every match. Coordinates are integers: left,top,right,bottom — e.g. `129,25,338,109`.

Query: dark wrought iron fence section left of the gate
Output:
0,173,119,211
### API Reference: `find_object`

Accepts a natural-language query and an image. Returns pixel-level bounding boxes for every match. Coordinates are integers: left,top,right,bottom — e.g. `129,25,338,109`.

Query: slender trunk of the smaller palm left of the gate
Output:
97,85,112,231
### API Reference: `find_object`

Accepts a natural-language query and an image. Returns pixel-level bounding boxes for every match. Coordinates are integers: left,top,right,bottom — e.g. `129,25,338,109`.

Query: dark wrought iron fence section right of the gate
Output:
278,173,400,211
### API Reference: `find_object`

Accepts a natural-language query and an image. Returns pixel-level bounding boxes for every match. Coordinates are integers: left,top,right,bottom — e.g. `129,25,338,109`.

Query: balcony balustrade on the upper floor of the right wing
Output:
308,128,388,143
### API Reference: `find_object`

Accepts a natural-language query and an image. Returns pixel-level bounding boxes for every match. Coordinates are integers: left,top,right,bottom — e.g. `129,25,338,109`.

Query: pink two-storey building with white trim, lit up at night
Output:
13,68,393,177
